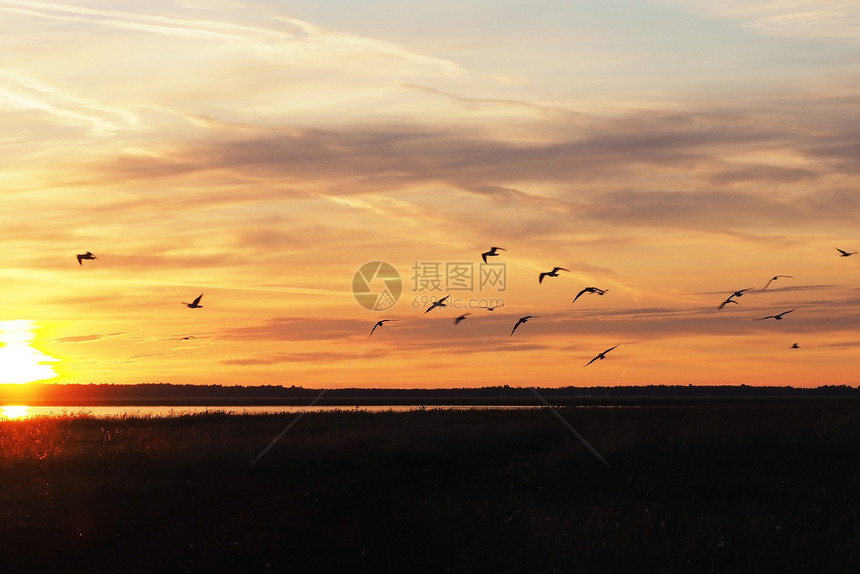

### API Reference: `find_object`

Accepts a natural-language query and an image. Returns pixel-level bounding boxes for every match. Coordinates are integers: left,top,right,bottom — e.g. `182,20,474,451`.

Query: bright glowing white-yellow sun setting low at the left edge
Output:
0,320,57,384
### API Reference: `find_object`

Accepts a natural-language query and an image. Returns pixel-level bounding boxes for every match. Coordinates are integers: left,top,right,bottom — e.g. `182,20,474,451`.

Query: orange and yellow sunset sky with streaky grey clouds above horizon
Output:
0,0,860,388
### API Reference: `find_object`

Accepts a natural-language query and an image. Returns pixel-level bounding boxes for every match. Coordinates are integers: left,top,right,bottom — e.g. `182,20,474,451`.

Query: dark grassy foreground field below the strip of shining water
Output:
0,400,860,573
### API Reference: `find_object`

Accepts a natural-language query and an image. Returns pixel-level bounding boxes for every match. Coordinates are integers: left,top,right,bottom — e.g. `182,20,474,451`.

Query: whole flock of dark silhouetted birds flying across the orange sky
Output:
76,247,858,367
